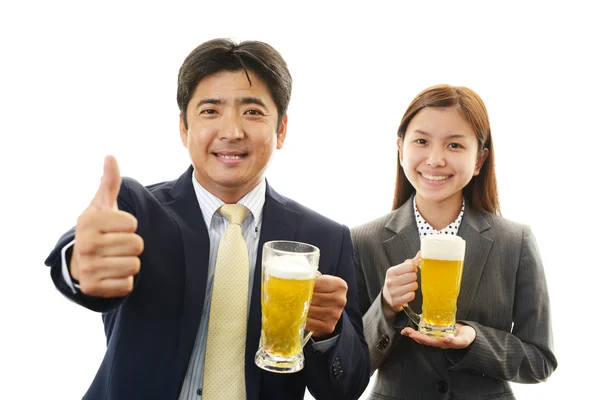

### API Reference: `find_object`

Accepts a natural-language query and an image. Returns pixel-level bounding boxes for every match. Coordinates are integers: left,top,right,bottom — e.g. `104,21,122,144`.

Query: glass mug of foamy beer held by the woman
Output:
404,235,466,337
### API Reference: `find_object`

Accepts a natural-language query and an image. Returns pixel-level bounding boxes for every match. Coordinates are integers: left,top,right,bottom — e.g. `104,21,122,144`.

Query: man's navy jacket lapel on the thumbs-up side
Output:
164,167,210,394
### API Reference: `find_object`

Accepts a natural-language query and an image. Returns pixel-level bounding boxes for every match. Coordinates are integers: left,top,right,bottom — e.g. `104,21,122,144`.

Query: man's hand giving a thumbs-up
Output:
69,156,144,298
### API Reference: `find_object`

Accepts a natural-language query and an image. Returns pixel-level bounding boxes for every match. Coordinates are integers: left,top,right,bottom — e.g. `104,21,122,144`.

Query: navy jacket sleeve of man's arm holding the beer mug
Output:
304,226,369,400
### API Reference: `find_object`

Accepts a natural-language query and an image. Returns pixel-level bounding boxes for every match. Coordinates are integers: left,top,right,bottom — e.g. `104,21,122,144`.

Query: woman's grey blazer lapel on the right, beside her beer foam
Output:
456,202,494,320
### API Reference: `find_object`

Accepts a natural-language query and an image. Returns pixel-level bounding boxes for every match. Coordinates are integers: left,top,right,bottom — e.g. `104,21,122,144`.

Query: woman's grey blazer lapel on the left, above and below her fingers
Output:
383,197,423,314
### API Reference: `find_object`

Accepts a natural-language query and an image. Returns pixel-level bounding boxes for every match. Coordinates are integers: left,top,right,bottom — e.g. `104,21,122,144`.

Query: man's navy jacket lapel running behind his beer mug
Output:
246,184,300,400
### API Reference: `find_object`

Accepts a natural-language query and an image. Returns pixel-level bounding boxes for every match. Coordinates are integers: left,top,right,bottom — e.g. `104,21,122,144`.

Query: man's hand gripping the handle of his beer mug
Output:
305,275,348,339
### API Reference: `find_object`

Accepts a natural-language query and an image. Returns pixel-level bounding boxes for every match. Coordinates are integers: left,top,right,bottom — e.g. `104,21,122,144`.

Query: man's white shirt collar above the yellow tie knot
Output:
192,173,267,229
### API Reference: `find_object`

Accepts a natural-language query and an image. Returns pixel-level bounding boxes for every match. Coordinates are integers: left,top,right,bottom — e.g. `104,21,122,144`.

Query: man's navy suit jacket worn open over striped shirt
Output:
46,167,370,400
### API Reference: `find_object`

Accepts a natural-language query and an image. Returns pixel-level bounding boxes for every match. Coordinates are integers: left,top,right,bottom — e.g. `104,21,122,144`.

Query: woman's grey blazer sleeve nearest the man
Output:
354,234,410,375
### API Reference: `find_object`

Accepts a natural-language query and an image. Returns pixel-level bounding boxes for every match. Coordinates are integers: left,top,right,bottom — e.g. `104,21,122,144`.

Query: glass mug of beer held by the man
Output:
254,241,320,373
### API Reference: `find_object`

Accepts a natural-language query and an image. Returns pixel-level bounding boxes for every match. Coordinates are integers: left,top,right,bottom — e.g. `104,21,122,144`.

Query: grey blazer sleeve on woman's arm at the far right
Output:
447,227,557,383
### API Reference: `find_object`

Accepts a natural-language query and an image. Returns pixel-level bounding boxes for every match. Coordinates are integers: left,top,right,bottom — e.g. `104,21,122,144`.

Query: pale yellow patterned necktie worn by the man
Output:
202,204,250,400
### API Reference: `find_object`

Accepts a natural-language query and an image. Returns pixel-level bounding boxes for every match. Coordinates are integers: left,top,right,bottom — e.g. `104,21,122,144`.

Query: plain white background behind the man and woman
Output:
0,0,600,399
